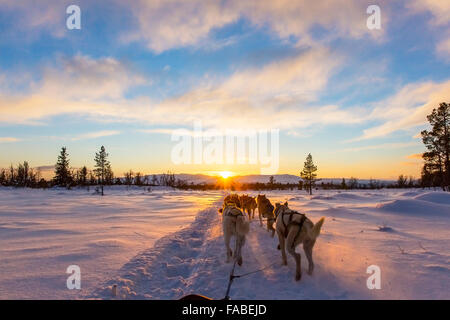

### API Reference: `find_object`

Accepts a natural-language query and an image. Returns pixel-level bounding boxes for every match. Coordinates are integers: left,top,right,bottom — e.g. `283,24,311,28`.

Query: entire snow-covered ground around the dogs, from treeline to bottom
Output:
0,188,450,299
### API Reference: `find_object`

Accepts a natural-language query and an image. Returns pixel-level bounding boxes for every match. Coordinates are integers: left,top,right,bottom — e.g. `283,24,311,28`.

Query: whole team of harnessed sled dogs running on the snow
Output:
219,194,325,281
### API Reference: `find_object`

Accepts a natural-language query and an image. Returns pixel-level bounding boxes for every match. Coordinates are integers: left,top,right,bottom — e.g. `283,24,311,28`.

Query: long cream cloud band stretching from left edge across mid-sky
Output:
0,47,365,133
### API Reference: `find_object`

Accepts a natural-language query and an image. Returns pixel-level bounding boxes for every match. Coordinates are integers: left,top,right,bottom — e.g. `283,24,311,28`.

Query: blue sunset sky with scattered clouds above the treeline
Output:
0,0,450,179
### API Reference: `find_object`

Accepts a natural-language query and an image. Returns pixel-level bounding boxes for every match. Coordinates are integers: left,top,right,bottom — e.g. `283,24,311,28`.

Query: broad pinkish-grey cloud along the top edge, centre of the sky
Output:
123,0,389,53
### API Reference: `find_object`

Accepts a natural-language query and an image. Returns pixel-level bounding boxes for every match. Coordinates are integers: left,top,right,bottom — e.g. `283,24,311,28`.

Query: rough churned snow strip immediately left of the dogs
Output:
87,202,221,299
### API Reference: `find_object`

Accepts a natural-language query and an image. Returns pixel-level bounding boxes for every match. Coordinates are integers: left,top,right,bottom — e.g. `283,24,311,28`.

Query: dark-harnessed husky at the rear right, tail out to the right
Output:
274,202,325,281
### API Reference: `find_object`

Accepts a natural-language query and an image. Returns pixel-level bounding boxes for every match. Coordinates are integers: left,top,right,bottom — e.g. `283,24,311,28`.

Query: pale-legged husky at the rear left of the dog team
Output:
219,202,250,266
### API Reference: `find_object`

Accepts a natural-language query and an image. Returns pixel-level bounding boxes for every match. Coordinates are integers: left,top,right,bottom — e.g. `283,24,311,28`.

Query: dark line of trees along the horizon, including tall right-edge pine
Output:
0,103,450,194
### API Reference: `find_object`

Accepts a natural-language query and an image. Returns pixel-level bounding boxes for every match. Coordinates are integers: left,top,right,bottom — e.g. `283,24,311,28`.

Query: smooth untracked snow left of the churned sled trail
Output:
0,187,221,299
